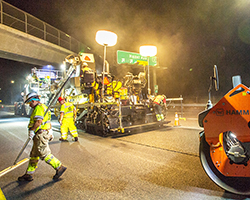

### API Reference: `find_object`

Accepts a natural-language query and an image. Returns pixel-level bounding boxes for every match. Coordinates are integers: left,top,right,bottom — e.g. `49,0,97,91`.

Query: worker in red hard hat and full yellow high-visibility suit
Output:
58,97,78,142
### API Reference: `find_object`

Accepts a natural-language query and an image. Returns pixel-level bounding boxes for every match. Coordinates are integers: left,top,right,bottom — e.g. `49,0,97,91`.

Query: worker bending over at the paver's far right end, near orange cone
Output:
153,95,167,121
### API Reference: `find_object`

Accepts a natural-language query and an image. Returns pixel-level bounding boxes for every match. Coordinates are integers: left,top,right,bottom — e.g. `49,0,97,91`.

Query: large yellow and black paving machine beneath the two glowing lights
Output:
54,52,169,137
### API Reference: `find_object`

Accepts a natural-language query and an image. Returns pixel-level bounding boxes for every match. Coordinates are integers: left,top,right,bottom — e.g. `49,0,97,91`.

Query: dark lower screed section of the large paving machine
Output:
84,95,161,137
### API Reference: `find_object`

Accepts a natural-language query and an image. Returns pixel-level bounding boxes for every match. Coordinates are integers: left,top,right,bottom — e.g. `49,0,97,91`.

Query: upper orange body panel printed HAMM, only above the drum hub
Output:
203,84,250,145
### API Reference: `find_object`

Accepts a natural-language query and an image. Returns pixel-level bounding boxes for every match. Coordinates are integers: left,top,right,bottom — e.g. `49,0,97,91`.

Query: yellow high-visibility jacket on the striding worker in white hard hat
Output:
28,103,51,132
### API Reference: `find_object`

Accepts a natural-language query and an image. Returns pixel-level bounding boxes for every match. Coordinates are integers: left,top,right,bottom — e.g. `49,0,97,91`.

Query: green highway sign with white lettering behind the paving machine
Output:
117,50,157,66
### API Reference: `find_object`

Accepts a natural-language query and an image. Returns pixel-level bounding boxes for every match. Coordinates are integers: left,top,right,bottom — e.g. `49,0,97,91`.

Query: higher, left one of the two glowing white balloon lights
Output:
95,30,117,47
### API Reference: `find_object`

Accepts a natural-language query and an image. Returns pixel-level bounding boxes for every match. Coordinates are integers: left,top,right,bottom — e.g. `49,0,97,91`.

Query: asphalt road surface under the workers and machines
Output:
0,111,249,200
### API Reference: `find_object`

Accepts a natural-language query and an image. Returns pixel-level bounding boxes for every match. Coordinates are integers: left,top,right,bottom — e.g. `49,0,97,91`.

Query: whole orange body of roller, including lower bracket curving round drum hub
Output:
203,84,250,177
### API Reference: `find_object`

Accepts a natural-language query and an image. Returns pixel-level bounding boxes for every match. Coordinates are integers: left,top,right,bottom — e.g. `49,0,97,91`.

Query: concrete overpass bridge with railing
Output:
0,0,90,67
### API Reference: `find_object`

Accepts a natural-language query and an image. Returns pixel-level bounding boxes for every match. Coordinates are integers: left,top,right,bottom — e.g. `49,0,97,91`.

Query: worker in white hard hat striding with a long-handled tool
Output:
18,93,67,181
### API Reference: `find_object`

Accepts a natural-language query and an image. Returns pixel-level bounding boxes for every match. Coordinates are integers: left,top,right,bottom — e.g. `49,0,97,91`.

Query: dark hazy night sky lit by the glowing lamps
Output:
0,0,250,103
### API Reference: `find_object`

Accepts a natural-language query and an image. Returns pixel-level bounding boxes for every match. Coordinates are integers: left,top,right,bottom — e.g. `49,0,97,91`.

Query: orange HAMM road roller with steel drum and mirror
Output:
198,66,250,195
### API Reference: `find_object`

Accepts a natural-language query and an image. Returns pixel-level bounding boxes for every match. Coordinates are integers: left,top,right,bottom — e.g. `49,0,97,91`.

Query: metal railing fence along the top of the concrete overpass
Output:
0,0,88,53
